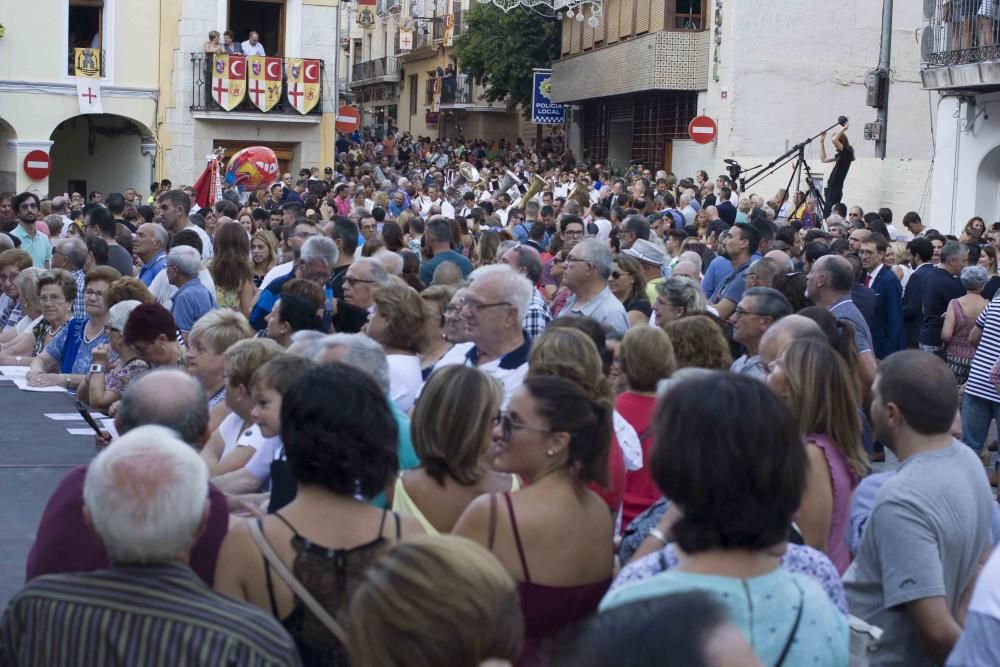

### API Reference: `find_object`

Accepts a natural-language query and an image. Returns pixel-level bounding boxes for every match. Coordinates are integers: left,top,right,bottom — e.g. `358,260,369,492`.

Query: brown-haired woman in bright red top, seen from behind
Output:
615,325,675,526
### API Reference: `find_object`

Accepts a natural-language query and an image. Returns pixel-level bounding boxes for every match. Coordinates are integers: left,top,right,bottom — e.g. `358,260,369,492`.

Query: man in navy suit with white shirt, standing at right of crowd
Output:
858,234,906,359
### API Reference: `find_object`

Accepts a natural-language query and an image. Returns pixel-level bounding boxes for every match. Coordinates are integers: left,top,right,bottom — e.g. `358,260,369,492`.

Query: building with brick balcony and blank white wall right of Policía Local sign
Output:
552,0,933,222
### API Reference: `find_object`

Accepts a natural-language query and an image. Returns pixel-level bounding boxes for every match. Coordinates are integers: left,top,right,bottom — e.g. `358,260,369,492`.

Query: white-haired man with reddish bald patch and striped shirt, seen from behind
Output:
0,426,299,667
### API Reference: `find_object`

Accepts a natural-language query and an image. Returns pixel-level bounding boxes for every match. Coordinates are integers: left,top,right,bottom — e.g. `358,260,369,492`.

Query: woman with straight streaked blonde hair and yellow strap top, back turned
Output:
392,366,520,535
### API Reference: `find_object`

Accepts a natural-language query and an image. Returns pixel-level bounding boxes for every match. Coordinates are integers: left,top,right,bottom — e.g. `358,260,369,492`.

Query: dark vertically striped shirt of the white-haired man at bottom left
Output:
0,563,300,667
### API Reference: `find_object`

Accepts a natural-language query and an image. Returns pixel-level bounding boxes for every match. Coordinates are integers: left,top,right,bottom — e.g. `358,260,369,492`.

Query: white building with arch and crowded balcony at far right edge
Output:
920,0,1000,234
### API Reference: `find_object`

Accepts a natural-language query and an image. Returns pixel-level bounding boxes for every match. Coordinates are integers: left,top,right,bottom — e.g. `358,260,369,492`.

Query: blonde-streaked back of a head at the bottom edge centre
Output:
348,535,524,667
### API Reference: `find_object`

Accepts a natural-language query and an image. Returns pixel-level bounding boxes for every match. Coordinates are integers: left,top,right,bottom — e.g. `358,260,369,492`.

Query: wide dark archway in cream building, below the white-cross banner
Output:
49,114,156,195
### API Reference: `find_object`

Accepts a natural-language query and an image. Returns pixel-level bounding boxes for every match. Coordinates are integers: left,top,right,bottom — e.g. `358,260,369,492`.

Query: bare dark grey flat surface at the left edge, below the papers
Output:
0,379,94,607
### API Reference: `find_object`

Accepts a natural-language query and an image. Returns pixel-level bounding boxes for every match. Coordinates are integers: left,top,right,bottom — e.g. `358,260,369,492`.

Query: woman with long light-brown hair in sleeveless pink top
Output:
767,340,868,574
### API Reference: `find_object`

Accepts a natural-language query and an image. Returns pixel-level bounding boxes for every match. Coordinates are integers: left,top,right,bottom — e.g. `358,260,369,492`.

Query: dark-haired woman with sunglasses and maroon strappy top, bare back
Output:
453,376,614,666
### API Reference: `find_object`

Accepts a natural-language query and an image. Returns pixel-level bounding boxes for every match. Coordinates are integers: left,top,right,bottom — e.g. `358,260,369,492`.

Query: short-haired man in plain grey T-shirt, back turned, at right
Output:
843,351,993,667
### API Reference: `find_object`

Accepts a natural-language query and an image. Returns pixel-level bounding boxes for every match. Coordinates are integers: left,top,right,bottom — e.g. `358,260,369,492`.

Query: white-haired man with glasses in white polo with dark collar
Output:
437,265,535,406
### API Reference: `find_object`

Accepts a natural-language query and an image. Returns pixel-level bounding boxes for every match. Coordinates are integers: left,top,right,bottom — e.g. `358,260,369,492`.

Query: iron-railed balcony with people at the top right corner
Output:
920,0,1000,90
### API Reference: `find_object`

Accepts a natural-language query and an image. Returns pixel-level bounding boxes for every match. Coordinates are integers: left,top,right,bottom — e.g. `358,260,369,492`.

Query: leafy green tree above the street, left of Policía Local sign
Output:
455,2,561,116
